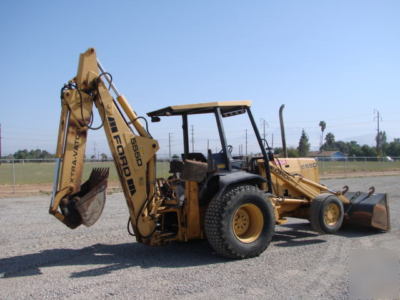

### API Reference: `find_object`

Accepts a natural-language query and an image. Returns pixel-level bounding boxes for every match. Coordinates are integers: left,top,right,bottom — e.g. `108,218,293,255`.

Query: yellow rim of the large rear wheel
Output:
232,204,264,243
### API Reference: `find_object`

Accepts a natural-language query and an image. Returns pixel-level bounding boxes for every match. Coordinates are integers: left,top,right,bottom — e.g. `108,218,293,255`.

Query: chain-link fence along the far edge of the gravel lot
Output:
0,157,400,196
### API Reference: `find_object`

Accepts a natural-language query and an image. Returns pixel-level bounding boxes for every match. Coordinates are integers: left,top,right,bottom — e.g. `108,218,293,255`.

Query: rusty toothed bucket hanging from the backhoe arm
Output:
74,168,109,226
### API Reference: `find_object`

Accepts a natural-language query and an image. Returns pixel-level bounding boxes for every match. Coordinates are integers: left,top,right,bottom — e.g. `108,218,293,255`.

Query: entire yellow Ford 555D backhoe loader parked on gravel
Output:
49,49,390,258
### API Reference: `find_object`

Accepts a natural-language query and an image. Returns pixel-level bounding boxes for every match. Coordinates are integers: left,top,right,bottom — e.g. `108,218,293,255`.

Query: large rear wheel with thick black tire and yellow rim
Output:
204,185,275,258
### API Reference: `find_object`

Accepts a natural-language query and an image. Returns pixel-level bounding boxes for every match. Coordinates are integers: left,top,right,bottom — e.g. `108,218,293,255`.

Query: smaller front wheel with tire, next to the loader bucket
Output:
310,194,344,234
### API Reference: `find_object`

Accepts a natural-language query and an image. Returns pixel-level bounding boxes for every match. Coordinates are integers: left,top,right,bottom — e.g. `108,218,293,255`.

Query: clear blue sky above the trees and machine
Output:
0,0,400,156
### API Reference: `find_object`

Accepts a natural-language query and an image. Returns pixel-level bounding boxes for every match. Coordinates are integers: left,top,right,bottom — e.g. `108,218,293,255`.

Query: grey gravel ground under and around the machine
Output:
0,176,400,299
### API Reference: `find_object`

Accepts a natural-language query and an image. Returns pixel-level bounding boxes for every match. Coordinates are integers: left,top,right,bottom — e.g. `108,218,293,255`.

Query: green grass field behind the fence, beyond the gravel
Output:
0,161,400,185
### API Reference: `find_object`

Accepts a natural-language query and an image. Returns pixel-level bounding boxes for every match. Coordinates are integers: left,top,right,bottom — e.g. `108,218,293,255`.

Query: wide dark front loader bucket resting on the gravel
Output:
344,188,390,231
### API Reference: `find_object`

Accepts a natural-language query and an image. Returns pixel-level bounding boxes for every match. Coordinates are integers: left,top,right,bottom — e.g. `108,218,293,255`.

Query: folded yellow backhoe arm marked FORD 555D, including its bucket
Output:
50,48,159,242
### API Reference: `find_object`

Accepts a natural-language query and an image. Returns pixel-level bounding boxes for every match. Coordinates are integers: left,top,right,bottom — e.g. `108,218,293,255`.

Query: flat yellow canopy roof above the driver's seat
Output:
147,100,251,117
